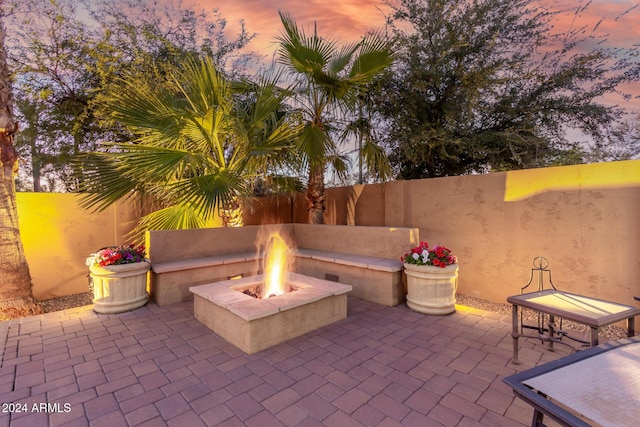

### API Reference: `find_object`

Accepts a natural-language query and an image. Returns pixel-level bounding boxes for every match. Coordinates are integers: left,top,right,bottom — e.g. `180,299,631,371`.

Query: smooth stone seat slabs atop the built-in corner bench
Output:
151,248,403,273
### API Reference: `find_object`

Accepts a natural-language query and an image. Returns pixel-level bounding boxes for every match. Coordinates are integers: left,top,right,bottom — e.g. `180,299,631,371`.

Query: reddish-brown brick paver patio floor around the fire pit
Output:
0,297,568,427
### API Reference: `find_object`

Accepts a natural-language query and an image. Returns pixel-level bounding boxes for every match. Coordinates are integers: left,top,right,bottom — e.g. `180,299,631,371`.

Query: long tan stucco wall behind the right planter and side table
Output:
256,161,640,304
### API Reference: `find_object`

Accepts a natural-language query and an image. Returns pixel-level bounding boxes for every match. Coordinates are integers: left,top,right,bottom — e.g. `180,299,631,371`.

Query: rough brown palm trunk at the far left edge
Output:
0,7,33,309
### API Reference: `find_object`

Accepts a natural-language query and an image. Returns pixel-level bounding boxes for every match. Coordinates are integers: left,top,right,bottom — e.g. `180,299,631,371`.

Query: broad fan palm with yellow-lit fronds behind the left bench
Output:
83,59,299,235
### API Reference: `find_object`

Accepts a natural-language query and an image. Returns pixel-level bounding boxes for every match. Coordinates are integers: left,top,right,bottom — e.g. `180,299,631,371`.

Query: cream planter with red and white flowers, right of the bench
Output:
402,242,458,315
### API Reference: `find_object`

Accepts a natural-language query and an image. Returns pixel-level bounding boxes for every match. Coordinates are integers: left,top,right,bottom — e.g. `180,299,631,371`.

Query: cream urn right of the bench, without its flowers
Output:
404,263,458,315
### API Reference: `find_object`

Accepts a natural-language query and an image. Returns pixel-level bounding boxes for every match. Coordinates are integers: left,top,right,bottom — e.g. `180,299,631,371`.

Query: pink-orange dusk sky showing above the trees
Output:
194,0,640,113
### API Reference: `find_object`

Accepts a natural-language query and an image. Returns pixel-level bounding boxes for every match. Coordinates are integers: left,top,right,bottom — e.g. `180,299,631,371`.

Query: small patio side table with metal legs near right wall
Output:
507,289,640,364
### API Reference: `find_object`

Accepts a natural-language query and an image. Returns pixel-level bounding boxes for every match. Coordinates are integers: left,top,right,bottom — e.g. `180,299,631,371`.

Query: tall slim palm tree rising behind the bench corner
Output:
278,12,394,224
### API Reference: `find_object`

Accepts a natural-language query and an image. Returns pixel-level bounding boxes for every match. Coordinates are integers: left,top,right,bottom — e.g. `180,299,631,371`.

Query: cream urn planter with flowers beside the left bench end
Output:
87,245,151,313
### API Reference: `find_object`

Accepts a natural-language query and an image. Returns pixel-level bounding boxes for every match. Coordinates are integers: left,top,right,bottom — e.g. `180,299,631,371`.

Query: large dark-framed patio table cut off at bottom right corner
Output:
503,337,640,427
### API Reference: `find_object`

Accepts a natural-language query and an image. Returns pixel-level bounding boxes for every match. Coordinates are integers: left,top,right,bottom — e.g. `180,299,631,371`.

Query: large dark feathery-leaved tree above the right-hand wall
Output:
376,0,640,178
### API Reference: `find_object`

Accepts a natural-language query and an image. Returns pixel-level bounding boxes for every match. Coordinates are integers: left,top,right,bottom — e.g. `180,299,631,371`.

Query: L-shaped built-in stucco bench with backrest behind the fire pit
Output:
146,224,418,306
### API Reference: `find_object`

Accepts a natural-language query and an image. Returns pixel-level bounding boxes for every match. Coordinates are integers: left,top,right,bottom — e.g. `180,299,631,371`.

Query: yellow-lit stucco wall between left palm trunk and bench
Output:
17,193,139,300
